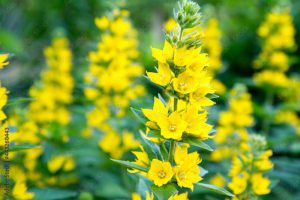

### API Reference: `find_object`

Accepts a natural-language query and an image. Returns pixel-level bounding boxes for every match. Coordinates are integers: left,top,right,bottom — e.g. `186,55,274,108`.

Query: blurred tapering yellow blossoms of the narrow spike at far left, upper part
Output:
28,37,74,125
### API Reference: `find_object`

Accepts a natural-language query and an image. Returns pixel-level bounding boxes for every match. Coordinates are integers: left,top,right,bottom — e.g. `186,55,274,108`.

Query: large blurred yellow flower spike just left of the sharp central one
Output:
83,10,144,158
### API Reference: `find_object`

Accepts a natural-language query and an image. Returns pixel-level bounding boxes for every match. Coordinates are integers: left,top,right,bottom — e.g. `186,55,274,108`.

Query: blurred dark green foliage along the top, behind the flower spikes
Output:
0,0,300,95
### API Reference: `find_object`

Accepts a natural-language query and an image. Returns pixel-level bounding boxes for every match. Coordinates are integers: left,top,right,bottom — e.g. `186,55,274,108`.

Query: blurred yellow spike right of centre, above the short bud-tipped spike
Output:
211,87,254,161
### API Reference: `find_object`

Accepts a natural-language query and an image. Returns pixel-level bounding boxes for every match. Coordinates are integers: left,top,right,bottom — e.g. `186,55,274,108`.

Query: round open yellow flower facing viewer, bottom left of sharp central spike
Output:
148,159,173,187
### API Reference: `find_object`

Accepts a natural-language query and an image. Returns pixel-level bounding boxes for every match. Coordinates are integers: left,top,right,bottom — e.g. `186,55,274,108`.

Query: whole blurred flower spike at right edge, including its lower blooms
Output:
254,10,300,138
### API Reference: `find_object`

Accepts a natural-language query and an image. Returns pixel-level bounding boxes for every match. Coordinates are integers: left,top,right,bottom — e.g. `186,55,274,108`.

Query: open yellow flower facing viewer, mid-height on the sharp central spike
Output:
157,112,187,140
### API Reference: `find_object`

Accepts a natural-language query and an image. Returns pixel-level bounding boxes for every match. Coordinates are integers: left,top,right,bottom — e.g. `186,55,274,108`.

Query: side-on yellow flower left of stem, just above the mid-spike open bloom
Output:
142,97,168,122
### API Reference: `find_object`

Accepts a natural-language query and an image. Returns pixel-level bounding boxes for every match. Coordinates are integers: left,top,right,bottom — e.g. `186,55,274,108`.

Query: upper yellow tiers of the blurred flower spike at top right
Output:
254,10,296,88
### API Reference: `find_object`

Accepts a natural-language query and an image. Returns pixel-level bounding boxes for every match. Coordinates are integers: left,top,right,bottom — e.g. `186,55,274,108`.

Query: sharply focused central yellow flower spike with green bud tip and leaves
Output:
112,0,230,199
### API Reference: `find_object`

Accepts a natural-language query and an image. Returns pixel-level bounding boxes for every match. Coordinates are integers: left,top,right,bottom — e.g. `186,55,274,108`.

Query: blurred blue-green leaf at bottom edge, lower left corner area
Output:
32,187,77,200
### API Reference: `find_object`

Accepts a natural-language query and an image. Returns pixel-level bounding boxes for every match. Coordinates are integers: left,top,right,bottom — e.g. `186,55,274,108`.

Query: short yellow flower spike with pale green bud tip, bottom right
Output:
228,135,273,200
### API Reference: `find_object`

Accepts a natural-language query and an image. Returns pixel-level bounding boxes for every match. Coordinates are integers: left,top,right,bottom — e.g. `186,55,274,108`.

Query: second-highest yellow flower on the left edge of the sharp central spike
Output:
147,62,172,86
